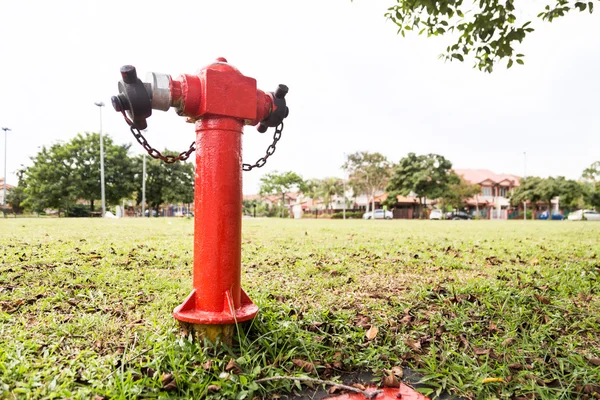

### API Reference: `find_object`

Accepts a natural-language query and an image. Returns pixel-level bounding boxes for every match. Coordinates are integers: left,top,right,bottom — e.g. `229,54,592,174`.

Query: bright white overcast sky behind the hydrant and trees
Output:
0,0,600,193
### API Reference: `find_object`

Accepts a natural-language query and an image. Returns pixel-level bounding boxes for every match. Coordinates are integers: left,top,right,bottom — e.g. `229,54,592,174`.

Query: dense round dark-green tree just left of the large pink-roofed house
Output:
387,153,456,217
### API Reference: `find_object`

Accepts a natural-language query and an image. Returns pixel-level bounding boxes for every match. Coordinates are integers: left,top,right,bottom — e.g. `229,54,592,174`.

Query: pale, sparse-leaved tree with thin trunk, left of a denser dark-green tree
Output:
342,151,390,220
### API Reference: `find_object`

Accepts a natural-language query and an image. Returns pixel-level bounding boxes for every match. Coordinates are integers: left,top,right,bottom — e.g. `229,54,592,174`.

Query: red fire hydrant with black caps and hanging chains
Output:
112,58,288,343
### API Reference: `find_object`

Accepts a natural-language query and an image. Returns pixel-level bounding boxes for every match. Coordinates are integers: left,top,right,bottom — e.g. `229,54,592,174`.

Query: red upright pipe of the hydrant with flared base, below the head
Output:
173,117,258,325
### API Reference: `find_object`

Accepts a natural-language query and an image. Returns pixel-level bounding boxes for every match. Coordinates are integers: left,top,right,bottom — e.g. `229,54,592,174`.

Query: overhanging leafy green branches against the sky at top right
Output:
385,0,594,72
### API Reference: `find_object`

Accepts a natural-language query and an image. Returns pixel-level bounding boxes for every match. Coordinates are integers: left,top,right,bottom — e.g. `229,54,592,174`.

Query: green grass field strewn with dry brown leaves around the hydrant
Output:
0,218,600,400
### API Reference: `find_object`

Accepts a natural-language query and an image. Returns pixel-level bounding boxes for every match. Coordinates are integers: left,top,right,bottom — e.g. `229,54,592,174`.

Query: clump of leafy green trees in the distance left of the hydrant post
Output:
15,133,194,213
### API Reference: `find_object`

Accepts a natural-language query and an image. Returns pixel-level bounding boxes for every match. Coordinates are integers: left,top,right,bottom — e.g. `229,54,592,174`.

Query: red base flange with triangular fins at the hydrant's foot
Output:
173,289,258,325
